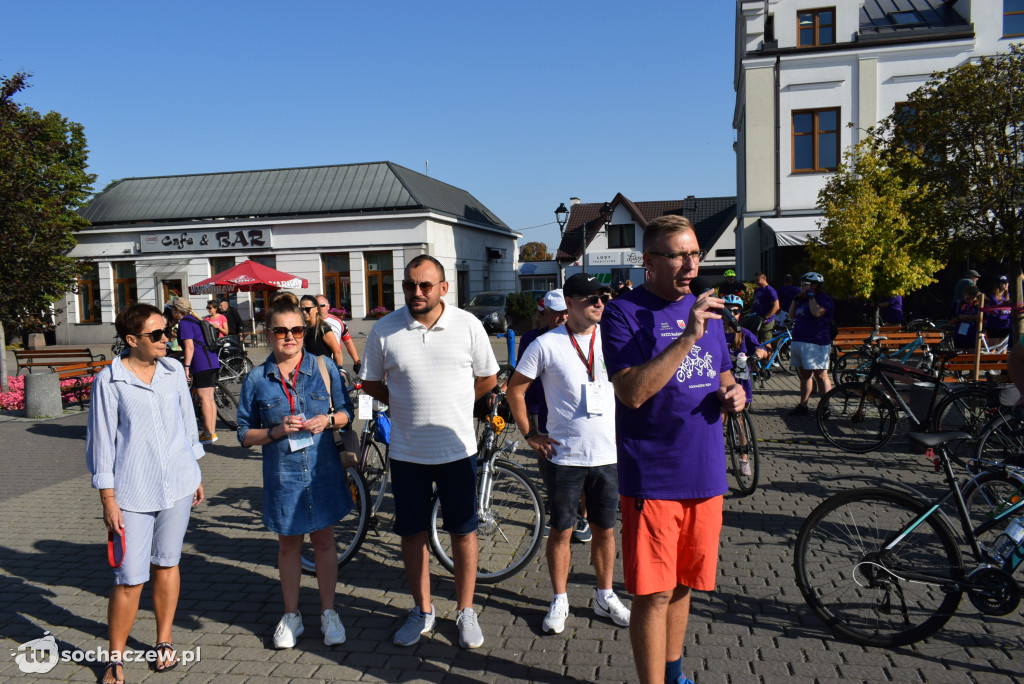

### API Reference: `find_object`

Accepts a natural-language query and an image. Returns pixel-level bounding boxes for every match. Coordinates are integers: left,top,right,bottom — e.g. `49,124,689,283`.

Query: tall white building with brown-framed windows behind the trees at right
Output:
733,0,1024,279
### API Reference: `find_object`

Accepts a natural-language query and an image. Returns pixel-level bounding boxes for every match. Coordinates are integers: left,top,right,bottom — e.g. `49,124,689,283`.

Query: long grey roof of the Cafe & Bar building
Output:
80,162,511,232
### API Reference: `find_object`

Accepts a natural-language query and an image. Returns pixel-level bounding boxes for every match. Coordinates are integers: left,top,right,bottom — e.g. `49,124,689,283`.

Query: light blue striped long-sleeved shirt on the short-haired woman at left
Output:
85,356,204,512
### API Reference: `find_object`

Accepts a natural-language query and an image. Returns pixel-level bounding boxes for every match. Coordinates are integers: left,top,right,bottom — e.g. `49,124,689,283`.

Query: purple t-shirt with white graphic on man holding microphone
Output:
601,288,732,500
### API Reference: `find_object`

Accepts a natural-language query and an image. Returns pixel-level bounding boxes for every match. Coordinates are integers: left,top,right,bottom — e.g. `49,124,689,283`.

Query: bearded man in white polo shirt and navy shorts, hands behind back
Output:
360,254,498,648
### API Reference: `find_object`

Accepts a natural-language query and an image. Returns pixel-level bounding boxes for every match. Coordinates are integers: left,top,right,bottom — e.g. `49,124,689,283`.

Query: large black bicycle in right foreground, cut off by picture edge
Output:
794,432,1024,647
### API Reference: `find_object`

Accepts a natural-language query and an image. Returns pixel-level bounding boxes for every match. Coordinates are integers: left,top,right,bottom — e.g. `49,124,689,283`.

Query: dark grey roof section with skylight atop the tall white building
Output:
858,0,971,42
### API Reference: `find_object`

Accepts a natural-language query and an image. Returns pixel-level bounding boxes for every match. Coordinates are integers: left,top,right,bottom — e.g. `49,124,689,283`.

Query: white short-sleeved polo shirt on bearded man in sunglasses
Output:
360,304,498,465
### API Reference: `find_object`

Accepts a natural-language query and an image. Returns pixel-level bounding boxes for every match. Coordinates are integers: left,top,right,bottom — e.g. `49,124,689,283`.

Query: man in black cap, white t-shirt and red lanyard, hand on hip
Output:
508,273,630,634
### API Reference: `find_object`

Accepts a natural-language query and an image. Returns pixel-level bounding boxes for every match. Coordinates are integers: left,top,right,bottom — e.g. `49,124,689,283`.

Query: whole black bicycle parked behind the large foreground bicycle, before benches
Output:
816,352,992,454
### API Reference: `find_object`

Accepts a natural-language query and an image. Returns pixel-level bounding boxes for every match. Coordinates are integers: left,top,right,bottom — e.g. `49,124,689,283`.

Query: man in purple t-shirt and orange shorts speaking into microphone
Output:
601,216,745,683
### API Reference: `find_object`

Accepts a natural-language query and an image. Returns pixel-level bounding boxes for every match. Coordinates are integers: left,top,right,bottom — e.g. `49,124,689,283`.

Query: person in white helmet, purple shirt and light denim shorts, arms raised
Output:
790,271,836,416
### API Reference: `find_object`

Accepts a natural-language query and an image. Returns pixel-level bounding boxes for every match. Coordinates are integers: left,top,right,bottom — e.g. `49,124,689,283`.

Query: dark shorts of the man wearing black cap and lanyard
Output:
548,463,618,529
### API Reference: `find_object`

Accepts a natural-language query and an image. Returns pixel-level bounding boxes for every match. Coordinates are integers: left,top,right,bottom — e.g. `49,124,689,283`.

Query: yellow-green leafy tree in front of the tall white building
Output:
807,138,943,301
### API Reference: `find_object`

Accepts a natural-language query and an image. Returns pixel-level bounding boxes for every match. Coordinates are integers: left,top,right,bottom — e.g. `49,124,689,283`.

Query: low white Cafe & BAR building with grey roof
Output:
56,162,521,344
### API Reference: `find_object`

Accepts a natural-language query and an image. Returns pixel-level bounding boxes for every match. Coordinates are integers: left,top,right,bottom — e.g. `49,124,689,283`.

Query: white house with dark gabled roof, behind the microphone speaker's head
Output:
555,193,736,286
